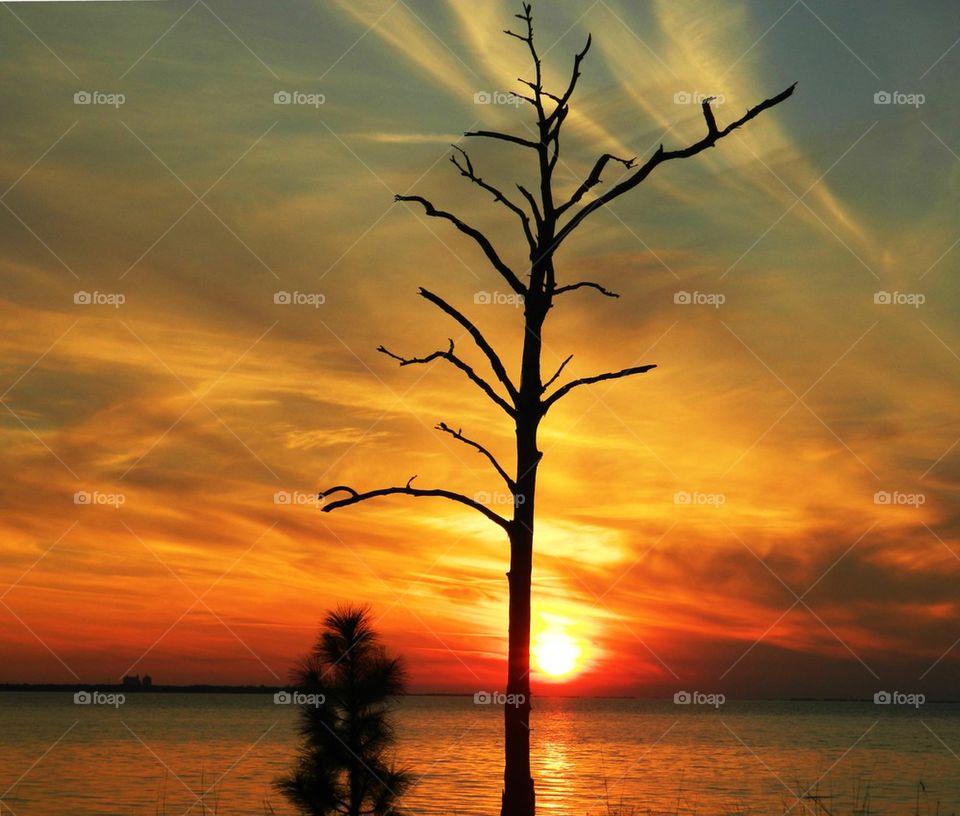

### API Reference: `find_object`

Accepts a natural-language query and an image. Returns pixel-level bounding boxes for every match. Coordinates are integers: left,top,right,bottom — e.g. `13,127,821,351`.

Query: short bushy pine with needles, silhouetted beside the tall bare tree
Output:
275,607,411,816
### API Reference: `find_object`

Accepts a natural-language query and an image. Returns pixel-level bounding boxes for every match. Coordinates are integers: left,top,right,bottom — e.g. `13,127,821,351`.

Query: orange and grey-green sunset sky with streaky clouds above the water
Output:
0,0,960,698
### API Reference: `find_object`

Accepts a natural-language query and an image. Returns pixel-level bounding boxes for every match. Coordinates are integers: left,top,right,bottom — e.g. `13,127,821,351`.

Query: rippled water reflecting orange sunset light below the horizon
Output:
0,693,960,816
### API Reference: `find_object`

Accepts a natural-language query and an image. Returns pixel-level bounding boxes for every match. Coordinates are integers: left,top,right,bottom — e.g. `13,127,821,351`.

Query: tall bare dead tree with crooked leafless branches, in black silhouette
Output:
321,3,796,816
